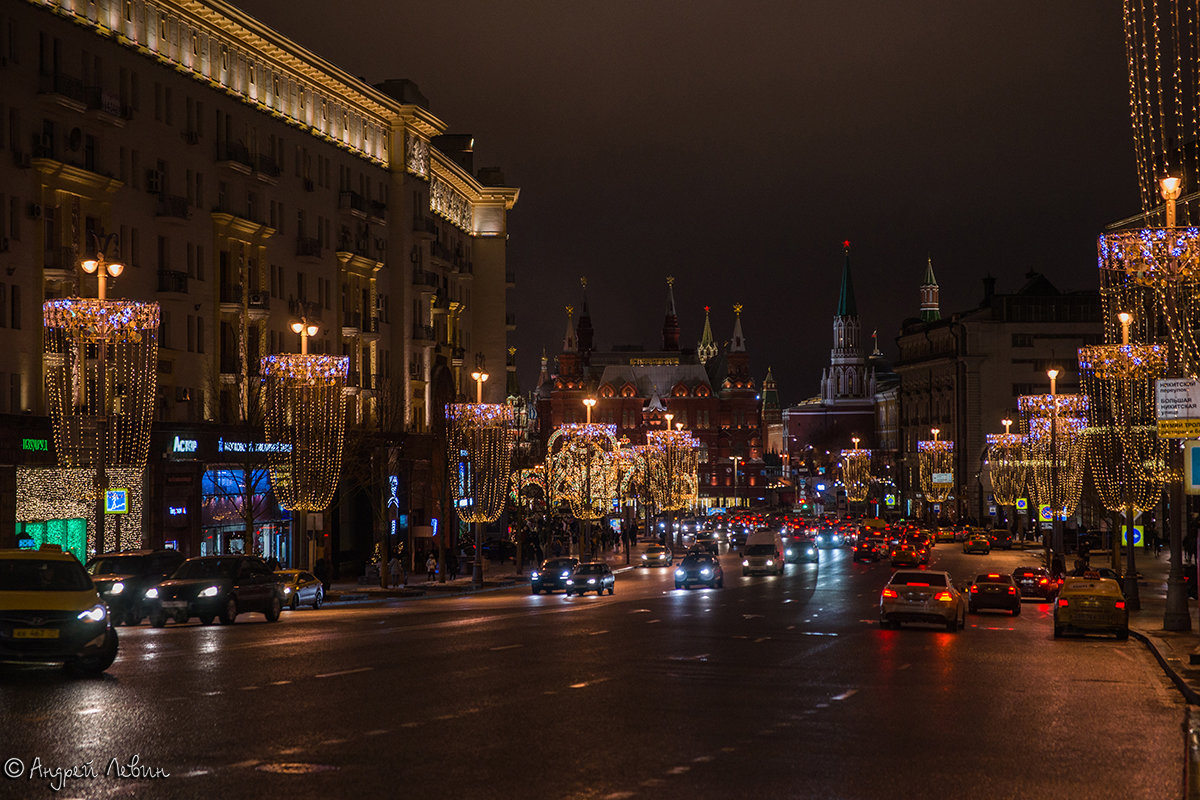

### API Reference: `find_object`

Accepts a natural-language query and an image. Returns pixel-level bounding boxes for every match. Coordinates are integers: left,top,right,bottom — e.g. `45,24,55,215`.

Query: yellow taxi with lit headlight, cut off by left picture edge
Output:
0,545,119,676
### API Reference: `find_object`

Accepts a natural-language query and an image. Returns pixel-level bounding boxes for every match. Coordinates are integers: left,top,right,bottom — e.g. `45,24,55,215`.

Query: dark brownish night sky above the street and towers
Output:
238,0,1139,404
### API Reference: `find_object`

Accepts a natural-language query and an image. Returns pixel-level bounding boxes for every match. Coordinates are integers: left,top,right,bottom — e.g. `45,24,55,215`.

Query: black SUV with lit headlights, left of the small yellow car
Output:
143,555,283,627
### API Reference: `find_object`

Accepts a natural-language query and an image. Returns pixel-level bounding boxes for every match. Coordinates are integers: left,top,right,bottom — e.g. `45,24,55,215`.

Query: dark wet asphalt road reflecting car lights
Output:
0,545,1183,800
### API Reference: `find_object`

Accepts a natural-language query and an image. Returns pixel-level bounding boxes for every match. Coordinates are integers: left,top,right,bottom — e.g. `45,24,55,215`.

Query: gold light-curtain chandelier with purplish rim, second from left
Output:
263,355,349,511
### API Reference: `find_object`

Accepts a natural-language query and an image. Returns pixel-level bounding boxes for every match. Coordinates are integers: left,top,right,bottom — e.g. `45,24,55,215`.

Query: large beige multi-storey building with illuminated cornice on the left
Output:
0,0,517,568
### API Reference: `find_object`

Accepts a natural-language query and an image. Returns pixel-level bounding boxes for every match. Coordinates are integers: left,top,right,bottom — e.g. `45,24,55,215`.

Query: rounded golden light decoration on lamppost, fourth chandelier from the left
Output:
546,422,619,519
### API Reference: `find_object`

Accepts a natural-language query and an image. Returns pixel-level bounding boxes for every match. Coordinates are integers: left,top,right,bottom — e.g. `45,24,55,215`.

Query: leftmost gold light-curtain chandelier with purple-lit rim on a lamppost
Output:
42,297,158,468
